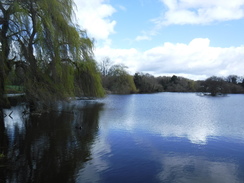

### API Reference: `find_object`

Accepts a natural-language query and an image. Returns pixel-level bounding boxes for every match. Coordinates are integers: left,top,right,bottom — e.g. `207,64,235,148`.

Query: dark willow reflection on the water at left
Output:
0,101,102,182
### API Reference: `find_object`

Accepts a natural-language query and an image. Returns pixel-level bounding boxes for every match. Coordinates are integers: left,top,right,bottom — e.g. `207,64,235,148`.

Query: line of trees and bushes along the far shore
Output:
99,58,244,96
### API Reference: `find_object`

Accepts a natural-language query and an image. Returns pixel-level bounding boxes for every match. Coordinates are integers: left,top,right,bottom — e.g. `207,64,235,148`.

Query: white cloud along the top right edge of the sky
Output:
153,0,244,26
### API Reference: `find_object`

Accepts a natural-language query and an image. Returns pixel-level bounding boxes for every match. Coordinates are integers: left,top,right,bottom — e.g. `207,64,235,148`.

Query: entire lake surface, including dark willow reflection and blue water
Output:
0,93,244,183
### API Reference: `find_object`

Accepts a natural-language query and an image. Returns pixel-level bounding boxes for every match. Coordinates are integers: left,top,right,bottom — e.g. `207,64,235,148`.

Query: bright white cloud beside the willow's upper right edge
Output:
74,0,116,40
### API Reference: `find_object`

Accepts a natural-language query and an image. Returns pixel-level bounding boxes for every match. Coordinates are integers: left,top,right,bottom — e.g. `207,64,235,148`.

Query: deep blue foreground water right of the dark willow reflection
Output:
74,128,244,183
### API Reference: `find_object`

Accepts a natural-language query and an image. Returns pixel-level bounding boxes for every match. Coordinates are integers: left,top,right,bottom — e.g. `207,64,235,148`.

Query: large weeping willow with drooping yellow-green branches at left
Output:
0,0,103,108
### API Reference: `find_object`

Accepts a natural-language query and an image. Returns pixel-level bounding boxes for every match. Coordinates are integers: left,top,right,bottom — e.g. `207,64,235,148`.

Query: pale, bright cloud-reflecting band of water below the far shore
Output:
99,93,244,144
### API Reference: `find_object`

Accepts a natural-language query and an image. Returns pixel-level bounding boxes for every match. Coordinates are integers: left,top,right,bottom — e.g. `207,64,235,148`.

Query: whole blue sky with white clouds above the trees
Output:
74,0,244,79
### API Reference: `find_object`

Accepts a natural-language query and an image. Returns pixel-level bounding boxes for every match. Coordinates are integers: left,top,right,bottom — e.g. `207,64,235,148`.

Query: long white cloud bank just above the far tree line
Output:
95,38,244,79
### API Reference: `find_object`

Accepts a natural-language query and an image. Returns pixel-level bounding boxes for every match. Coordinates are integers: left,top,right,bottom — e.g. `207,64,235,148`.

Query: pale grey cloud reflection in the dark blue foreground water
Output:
158,155,239,183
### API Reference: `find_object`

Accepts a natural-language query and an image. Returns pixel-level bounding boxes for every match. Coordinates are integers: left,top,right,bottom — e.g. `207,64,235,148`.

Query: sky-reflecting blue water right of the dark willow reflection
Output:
77,94,244,183
